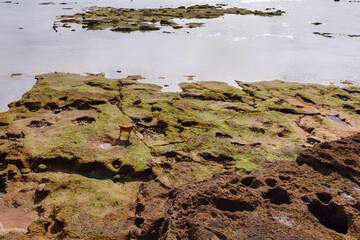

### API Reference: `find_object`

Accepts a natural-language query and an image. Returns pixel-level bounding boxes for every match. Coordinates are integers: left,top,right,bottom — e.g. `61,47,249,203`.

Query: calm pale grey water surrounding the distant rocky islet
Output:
0,0,360,111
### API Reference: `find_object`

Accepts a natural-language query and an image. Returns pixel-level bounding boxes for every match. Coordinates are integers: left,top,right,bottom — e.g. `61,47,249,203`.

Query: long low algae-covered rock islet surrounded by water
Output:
59,5,284,32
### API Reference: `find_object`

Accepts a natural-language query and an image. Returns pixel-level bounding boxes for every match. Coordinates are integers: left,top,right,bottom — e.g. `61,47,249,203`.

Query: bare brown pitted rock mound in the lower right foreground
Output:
160,134,360,239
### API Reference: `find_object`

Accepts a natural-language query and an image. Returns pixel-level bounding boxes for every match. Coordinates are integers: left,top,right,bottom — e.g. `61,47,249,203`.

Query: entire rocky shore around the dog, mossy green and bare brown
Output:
0,73,360,239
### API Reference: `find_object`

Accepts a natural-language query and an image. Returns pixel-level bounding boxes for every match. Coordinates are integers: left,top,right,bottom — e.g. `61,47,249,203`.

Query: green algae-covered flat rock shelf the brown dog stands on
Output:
0,72,360,239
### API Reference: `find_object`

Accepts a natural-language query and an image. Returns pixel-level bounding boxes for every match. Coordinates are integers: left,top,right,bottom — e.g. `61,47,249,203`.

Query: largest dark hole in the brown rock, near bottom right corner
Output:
308,200,349,234
